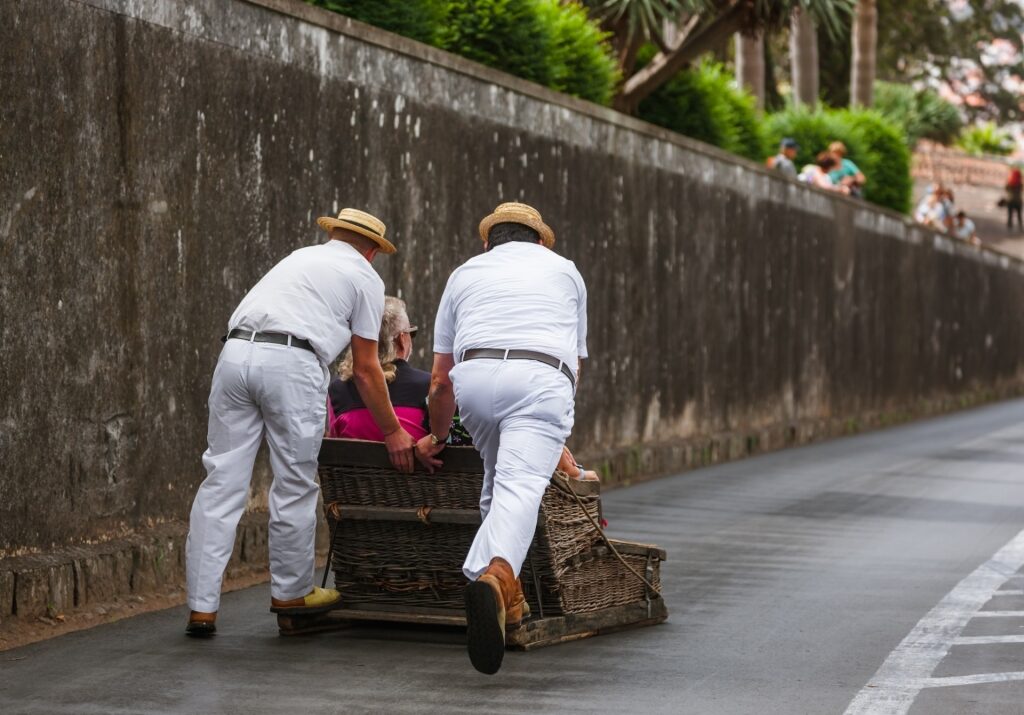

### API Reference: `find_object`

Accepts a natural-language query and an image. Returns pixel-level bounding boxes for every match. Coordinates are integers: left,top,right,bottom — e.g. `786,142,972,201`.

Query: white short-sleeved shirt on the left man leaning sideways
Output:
227,241,384,364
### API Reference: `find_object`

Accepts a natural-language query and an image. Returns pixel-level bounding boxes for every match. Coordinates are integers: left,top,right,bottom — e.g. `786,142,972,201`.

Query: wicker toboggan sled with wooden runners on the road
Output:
278,439,668,649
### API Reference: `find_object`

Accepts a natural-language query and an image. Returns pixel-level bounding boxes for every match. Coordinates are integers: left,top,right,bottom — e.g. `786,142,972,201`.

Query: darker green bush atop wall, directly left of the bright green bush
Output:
441,0,553,86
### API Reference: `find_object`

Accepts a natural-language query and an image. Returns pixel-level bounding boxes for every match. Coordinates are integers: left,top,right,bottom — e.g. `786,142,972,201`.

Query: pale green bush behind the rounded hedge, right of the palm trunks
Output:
874,82,964,150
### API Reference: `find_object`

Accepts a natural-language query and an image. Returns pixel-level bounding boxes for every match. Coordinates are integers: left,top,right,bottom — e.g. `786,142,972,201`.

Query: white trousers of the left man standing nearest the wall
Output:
185,339,329,613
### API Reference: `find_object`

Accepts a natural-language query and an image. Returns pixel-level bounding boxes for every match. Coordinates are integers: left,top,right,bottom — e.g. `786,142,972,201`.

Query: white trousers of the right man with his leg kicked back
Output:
451,360,573,580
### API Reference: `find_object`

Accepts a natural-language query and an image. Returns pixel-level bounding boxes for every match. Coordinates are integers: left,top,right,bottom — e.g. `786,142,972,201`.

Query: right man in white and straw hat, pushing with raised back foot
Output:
417,203,587,674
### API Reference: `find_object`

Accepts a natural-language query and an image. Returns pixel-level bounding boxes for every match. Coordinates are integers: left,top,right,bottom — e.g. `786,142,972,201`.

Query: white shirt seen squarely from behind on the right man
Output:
434,242,587,369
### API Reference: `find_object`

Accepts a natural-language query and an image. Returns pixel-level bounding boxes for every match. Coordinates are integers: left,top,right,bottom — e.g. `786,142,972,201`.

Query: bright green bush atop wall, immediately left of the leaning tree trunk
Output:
538,0,618,104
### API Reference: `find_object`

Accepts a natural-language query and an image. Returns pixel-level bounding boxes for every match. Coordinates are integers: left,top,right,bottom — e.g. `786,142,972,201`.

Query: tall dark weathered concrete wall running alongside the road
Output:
0,0,1024,594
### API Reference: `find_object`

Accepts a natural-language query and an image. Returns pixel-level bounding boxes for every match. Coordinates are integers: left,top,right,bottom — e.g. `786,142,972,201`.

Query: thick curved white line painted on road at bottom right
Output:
846,531,1024,715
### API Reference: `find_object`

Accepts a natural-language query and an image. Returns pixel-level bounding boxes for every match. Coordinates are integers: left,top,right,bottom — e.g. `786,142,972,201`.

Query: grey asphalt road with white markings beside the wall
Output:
0,401,1024,715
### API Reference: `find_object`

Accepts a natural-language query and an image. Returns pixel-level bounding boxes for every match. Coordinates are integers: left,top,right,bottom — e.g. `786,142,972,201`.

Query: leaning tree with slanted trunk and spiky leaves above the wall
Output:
585,0,854,113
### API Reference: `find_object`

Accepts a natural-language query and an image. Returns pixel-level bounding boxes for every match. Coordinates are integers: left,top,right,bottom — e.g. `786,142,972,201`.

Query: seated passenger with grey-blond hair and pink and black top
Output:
328,296,430,441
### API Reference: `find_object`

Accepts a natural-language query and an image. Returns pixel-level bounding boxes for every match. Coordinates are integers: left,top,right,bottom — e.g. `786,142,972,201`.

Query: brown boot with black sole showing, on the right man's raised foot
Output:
464,558,522,675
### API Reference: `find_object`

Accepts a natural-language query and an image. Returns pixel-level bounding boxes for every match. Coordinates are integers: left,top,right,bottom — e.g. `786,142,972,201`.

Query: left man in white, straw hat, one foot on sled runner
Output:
185,209,414,636
